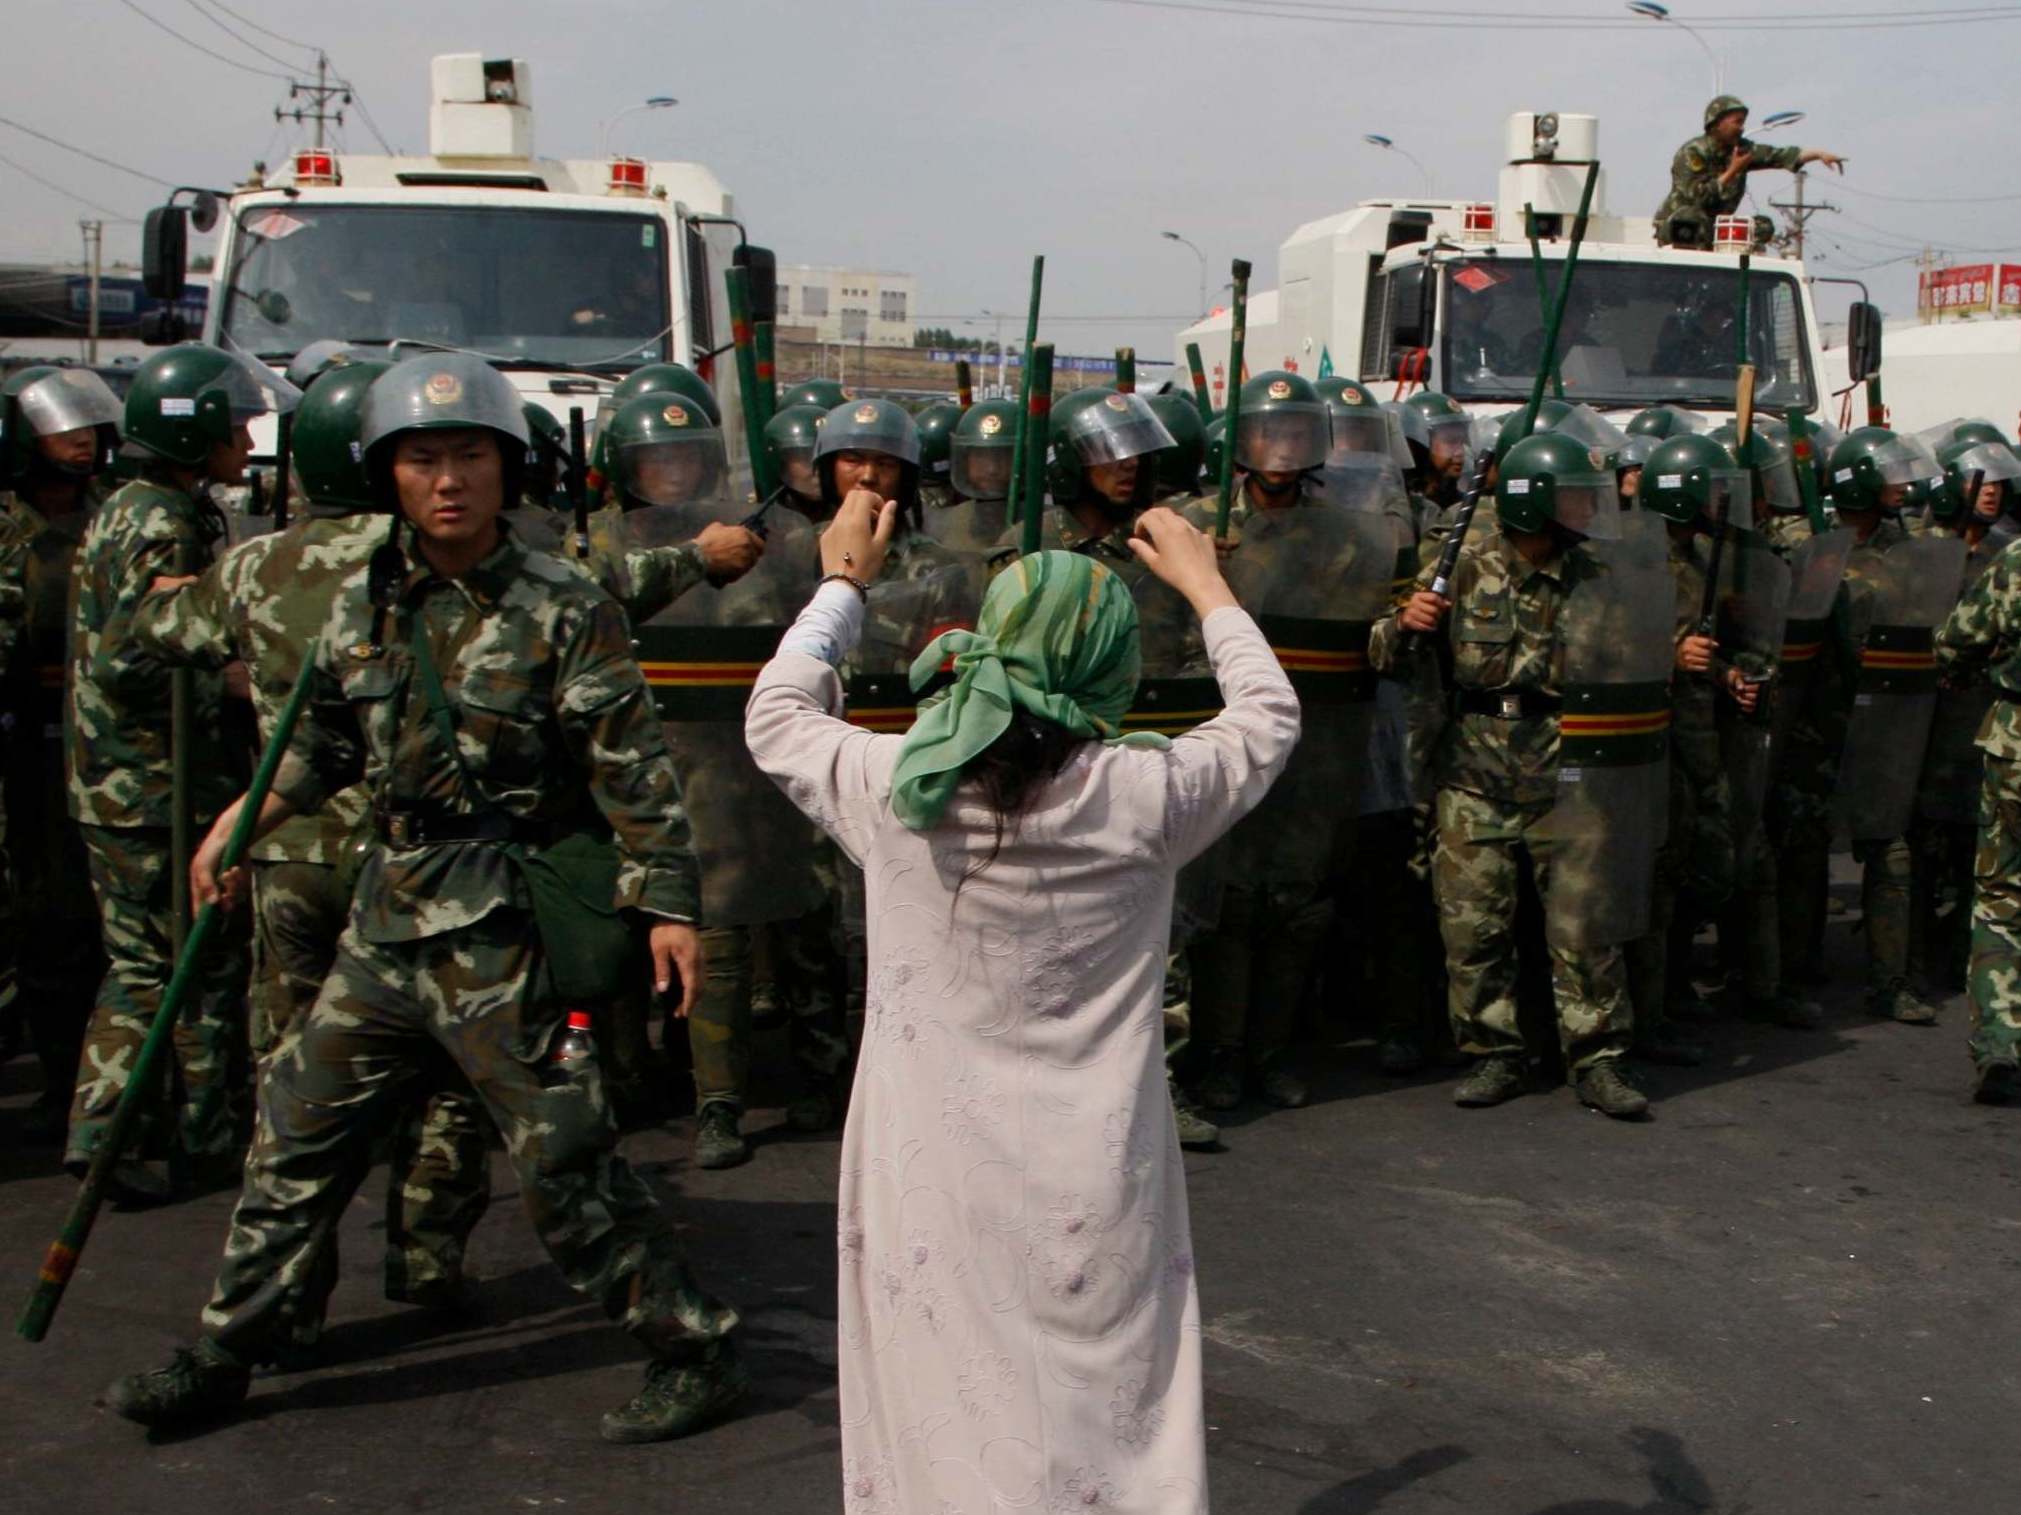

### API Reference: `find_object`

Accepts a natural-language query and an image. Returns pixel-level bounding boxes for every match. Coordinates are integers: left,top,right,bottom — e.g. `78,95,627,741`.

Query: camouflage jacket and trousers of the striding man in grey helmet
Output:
190,533,736,1359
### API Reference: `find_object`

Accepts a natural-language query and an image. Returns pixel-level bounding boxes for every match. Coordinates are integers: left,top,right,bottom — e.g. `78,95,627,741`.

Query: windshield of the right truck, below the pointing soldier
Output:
1441,259,1815,410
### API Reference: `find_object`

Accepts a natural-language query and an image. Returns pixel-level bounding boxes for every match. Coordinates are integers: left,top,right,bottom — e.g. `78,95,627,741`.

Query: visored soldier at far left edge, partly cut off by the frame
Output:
0,366,121,1141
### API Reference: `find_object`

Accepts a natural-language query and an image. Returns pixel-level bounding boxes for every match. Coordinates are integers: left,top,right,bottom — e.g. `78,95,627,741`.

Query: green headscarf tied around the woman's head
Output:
891,551,1170,830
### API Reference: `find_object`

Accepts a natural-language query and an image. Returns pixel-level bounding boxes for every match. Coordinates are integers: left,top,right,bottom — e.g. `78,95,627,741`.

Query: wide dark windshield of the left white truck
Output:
218,202,671,368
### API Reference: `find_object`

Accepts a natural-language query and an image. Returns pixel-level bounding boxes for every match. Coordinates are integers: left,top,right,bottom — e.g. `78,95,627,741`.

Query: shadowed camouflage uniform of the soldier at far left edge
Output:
0,487,105,1115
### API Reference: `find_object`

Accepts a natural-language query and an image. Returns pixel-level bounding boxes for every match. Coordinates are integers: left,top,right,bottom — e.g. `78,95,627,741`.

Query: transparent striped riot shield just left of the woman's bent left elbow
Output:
618,501,825,927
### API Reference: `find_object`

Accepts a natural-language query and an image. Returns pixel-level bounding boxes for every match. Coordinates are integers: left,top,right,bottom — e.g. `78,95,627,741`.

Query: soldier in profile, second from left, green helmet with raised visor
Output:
65,341,297,1198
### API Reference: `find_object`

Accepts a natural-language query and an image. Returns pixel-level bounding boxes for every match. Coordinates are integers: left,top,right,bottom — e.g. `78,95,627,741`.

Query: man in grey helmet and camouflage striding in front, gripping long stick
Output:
107,354,748,1442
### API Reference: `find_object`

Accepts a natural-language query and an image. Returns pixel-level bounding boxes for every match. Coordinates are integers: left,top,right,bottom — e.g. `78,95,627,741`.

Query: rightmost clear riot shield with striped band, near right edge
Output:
1837,537,1964,842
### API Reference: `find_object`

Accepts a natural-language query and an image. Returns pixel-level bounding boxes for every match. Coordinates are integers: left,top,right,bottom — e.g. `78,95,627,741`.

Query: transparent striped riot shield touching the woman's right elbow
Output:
1225,501,1401,885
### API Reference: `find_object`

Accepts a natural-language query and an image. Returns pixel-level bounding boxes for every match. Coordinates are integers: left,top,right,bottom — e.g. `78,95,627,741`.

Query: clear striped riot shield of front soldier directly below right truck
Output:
1536,511,1677,949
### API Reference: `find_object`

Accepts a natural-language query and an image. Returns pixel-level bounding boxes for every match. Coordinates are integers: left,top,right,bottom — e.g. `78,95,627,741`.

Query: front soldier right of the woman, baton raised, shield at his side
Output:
1368,434,1649,1119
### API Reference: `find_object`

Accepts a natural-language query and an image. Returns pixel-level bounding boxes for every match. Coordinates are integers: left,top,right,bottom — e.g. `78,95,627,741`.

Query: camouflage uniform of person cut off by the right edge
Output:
1936,549,2021,1069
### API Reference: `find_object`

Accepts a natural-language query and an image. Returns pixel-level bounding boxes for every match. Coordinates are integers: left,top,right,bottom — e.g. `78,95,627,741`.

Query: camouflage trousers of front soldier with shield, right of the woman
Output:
1431,788,1635,1073
